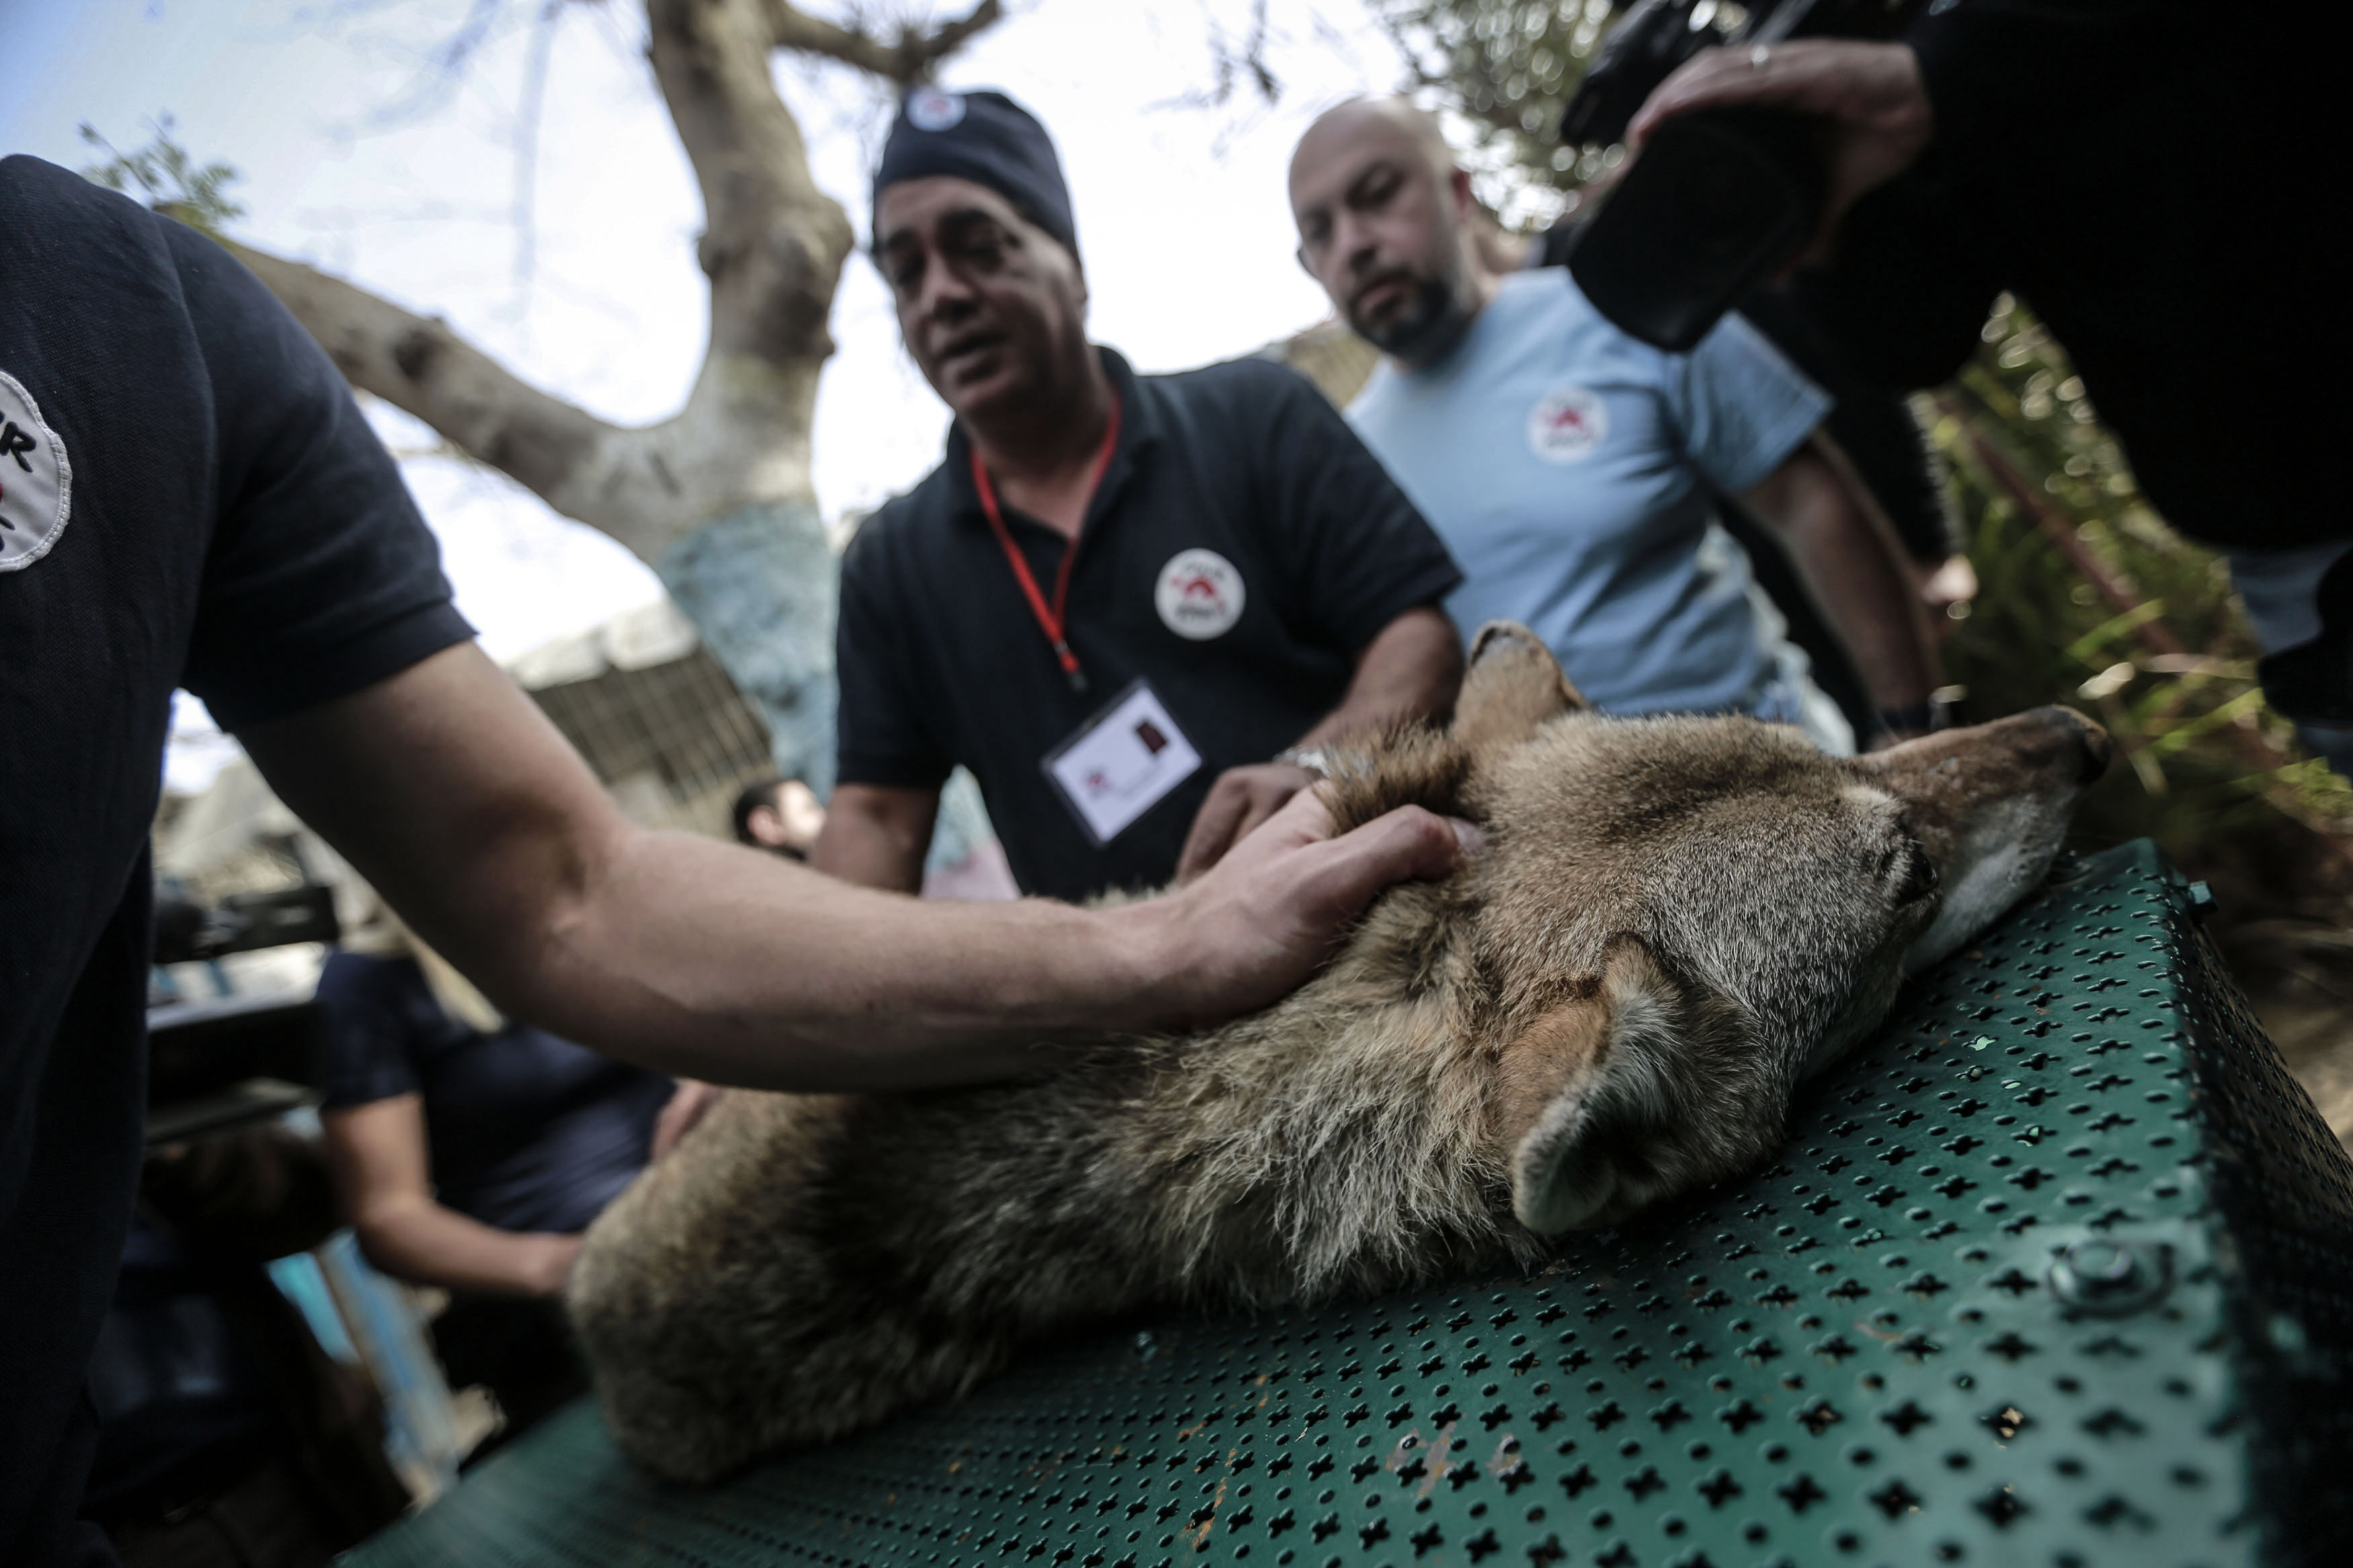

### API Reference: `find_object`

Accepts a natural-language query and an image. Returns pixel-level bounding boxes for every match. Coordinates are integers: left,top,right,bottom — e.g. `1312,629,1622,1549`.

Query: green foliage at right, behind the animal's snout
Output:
1927,296,2353,915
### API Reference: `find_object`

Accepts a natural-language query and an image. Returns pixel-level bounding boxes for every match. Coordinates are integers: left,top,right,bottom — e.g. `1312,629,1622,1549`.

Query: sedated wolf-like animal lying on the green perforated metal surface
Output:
569,625,2108,1481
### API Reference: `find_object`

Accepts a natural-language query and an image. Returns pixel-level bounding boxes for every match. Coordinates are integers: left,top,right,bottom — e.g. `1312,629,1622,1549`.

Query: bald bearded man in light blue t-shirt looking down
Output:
1289,99,1937,752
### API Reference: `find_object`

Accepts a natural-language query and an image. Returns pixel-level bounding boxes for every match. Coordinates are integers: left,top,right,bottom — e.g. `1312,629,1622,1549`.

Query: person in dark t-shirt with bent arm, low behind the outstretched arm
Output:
318,898,713,1462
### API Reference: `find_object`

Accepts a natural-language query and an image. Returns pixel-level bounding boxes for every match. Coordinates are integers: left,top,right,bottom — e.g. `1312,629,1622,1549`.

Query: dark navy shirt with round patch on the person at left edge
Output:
0,157,471,1568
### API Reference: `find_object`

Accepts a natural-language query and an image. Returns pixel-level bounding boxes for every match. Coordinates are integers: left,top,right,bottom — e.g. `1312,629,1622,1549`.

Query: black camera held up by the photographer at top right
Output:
1560,0,1918,353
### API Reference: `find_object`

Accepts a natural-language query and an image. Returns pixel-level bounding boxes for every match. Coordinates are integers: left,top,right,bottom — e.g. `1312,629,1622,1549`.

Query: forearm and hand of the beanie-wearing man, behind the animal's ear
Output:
1176,604,1464,882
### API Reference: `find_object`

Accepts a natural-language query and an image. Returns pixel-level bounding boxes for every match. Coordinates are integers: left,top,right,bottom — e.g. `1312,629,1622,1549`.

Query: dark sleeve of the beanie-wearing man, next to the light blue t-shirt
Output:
1238,360,1464,653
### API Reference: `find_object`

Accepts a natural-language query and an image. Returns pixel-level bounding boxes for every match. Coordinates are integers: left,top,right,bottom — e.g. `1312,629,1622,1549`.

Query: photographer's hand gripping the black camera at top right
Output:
1626,38,1937,261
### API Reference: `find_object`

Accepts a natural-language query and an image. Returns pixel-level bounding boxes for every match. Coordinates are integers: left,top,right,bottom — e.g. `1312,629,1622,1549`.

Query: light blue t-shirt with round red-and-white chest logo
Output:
1349,268,1831,719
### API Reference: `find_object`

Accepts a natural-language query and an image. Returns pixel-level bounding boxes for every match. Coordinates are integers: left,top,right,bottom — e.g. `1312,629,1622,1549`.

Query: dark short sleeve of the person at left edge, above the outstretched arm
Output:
165,223,473,729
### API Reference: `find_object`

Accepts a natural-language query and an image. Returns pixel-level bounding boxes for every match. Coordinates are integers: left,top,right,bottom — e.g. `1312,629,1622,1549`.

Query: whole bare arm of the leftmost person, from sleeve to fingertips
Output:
243,644,1468,1091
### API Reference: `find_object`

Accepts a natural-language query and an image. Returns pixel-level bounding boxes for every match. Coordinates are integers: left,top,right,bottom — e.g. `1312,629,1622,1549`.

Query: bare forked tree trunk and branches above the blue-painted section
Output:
231,0,1002,562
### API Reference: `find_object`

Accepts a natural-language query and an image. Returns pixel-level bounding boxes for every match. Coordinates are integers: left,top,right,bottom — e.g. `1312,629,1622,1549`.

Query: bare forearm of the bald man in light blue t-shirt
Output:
1744,438,1939,714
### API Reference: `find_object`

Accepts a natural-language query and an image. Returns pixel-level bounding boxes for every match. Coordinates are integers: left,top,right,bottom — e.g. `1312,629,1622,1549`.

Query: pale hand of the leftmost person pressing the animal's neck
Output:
1120,785,1480,1023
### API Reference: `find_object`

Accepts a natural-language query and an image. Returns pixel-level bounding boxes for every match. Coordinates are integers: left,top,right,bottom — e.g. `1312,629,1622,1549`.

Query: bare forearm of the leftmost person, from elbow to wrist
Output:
518,835,1167,1091
